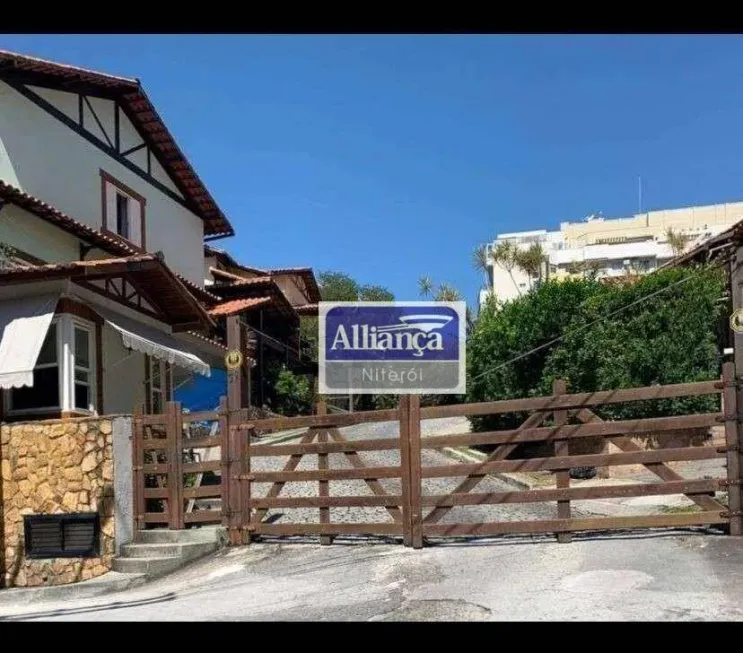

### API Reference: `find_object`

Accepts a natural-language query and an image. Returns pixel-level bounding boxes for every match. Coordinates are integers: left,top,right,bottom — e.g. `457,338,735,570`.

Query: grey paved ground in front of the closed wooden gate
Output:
0,531,743,621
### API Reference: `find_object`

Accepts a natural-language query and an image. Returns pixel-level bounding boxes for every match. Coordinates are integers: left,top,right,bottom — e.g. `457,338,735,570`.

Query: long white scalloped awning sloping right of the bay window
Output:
95,306,211,376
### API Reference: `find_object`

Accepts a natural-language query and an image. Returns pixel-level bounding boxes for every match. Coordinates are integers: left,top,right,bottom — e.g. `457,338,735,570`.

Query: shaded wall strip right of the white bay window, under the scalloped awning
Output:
101,323,145,415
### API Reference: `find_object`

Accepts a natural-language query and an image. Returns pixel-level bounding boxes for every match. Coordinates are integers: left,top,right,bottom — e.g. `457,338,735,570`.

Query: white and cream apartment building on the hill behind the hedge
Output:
480,202,743,304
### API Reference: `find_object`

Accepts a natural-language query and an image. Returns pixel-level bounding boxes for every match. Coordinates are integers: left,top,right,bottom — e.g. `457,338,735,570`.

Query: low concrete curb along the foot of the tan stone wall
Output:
0,571,149,607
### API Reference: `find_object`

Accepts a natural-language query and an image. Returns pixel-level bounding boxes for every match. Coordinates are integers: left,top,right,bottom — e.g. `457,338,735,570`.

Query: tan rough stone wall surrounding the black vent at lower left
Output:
0,417,114,587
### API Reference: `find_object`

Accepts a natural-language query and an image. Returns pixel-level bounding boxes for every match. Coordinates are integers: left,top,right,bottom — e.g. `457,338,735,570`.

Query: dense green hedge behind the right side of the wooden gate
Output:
467,268,726,430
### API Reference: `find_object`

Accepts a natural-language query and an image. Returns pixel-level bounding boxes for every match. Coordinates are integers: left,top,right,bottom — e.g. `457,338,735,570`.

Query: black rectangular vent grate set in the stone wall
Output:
23,512,100,558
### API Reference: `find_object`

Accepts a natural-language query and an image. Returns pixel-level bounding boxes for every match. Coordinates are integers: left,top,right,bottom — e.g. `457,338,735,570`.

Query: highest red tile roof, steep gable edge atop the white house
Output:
0,50,235,238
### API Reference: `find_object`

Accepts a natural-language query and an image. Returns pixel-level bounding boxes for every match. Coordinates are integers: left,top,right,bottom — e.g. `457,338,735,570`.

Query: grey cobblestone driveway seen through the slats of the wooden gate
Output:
251,418,582,524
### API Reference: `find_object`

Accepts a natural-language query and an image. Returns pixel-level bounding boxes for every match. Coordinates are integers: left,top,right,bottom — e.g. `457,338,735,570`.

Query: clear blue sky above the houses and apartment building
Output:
0,35,743,303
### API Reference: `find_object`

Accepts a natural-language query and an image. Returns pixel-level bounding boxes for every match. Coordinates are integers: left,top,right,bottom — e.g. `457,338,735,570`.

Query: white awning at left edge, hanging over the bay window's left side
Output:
0,293,59,389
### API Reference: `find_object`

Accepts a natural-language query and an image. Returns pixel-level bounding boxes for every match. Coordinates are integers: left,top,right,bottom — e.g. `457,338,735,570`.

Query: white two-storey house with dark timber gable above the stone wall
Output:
0,51,233,421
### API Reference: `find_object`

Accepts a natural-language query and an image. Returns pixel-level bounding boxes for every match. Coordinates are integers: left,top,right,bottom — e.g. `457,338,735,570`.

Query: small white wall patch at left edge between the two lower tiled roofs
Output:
0,204,79,263
